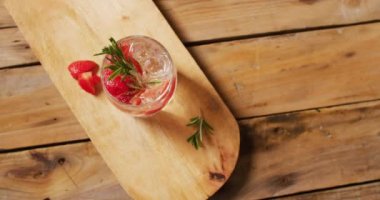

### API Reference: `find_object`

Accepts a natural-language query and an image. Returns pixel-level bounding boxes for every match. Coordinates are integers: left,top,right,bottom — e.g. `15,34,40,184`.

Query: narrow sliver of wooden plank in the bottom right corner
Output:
278,182,380,200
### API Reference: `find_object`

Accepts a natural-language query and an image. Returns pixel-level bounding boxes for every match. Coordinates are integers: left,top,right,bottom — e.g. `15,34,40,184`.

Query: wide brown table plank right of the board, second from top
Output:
192,22,380,117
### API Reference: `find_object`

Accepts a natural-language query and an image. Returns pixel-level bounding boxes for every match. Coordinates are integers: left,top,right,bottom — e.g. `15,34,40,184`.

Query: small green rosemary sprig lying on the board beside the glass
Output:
187,116,214,150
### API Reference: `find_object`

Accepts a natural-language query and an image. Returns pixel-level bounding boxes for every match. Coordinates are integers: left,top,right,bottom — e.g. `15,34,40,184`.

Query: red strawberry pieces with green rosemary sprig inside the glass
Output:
95,38,146,104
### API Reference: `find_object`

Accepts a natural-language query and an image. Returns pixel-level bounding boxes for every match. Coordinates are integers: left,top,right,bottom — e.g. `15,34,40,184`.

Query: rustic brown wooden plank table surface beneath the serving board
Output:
0,0,380,200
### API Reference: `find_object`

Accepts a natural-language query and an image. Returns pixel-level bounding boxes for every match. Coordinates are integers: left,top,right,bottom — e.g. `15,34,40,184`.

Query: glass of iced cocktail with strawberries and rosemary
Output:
101,36,177,116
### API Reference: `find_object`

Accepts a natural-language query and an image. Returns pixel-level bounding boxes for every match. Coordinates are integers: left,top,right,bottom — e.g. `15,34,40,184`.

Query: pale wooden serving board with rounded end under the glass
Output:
5,0,239,199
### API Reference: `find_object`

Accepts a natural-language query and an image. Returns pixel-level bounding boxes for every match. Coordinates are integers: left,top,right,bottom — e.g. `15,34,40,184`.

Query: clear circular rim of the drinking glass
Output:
100,35,177,109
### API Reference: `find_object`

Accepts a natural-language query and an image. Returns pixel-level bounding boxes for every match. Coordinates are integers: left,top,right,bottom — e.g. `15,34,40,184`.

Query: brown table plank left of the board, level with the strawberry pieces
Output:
0,66,88,150
